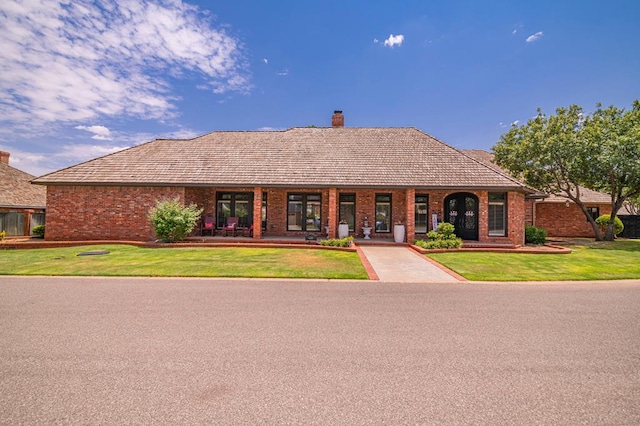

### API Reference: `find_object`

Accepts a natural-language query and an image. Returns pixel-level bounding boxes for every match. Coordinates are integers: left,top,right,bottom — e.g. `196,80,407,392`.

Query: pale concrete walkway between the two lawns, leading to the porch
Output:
360,246,460,283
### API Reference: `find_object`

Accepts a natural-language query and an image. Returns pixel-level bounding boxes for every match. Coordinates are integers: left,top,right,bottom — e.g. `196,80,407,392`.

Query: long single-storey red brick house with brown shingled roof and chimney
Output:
34,111,533,245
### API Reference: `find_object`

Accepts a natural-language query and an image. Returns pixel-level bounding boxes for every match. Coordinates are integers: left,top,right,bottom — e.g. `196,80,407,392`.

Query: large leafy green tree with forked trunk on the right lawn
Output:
493,100,640,240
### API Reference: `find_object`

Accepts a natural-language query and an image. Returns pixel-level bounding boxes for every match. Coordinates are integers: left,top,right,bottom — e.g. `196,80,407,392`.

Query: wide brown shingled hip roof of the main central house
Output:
35,127,529,192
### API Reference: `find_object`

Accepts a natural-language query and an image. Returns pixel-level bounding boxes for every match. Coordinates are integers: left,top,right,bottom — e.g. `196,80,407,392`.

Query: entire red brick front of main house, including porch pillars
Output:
46,186,525,244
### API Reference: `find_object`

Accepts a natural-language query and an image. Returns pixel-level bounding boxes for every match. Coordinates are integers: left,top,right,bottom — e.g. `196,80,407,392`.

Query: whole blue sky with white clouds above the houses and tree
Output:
0,0,640,175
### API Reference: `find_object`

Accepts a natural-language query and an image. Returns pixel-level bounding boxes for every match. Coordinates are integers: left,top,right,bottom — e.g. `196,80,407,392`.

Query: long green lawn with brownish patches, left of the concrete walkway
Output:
0,244,367,279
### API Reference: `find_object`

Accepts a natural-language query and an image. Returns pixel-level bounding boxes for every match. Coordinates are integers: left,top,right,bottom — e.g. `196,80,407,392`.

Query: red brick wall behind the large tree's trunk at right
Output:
535,203,611,238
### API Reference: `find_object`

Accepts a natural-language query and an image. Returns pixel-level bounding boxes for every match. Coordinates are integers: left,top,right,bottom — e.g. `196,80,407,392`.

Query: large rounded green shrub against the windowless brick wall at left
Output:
149,199,202,243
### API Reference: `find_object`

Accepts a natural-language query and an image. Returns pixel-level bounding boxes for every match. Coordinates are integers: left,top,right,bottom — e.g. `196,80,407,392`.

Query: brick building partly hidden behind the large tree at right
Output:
464,150,611,238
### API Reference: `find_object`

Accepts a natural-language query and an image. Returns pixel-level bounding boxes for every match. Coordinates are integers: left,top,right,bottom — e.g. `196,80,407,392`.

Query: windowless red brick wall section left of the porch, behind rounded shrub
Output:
45,186,185,241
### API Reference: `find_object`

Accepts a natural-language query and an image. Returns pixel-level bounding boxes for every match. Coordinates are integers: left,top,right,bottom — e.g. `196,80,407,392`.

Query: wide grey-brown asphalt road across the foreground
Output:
0,277,640,425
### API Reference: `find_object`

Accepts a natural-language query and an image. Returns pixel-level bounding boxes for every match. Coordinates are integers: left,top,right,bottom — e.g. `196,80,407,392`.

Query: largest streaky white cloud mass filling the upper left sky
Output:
0,0,250,131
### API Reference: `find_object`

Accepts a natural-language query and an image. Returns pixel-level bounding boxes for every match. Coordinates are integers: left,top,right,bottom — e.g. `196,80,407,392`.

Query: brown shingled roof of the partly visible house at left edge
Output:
0,152,47,209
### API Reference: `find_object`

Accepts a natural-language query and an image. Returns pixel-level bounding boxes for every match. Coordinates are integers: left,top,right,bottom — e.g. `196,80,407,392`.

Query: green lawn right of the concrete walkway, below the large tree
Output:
429,240,640,281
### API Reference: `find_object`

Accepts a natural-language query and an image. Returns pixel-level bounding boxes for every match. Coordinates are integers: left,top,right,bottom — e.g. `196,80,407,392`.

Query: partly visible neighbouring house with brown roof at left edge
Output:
0,151,47,236
